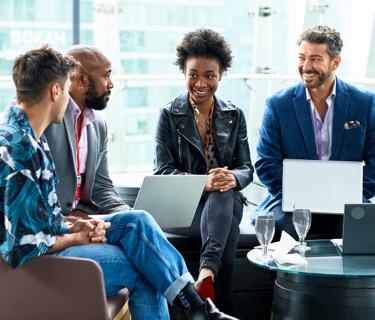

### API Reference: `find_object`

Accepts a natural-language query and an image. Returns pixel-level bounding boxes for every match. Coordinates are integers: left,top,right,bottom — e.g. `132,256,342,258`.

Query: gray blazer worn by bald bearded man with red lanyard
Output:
44,108,129,215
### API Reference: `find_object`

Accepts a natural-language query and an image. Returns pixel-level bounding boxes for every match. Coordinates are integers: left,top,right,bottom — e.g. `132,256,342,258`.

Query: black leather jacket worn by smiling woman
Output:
154,92,254,190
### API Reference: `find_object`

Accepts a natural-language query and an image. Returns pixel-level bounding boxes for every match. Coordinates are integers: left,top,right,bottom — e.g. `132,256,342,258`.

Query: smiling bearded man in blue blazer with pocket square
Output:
251,26,375,240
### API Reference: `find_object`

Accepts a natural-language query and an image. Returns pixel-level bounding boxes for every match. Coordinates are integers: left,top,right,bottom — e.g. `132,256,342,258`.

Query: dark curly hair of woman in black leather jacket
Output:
174,28,233,73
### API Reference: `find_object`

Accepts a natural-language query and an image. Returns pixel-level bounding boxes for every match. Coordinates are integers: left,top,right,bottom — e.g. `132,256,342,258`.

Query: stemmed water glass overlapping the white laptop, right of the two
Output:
293,203,311,252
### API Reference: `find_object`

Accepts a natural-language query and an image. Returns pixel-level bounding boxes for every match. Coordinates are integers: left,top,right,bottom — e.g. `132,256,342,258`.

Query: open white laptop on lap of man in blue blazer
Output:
282,159,363,214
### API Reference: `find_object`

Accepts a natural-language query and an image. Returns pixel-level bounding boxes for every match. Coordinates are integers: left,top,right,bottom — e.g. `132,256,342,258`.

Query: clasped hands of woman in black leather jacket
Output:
204,167,237,192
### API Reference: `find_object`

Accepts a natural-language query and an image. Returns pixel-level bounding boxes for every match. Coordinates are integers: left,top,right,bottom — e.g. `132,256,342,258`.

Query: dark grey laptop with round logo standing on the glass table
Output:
338,203,375,255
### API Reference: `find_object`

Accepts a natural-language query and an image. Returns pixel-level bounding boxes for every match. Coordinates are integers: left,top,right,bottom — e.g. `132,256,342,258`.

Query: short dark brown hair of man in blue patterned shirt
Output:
13,45,79,105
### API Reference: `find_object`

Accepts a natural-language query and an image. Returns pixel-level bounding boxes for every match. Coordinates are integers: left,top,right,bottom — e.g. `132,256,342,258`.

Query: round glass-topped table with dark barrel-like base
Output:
247,240,375,320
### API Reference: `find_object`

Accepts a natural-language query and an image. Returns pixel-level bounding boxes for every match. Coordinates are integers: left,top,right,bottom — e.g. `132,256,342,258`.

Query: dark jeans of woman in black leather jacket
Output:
166,189,243,314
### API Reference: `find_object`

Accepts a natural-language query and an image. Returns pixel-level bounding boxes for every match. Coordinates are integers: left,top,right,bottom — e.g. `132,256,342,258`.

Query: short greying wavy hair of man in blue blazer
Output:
297,25,343,58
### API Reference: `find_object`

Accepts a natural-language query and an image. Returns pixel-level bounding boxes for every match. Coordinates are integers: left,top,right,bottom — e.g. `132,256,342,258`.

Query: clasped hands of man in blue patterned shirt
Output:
64,216,111,244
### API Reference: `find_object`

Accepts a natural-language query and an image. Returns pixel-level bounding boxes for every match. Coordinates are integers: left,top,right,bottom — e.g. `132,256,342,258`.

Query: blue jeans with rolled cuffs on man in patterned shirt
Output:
54,210,194,320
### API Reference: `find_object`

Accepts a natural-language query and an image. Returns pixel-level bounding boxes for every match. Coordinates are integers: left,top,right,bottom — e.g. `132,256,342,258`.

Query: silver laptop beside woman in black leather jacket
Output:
133,175,207,228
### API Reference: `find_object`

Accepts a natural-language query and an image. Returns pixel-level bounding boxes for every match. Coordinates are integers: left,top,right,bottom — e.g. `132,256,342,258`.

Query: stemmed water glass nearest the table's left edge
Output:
255,212,275,263
